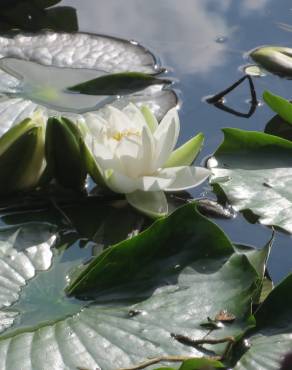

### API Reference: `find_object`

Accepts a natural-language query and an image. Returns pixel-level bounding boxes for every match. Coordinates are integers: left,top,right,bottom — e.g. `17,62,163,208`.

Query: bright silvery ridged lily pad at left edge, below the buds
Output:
0,225,56,332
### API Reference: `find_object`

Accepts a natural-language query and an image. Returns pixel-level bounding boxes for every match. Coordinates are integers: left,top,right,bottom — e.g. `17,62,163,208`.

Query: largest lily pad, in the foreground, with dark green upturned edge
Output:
0,204,264,370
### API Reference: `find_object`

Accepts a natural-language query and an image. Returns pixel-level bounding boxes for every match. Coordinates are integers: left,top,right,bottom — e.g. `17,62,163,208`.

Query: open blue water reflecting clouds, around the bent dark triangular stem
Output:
57,0,292,281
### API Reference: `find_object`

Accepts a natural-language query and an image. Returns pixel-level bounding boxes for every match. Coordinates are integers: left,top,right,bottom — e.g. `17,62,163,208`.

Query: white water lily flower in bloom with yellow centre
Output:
86,104,210,216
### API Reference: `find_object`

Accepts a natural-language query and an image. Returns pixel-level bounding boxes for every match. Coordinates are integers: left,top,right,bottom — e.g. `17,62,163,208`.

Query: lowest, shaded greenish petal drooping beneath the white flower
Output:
126,190,168,218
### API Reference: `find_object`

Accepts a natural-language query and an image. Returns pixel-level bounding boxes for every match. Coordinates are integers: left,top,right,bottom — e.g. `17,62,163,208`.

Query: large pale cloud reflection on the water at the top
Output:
64,0,234,73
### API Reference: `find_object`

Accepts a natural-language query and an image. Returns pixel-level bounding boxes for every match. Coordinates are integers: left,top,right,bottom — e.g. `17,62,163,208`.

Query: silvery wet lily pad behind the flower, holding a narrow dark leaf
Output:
0,32,177,134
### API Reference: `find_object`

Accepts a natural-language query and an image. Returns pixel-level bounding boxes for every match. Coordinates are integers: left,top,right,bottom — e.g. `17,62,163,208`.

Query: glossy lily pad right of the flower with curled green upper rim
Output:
209,129,292,233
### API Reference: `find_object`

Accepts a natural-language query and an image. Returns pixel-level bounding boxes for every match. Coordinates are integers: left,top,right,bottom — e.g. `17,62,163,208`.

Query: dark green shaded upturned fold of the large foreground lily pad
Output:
67,205,233,295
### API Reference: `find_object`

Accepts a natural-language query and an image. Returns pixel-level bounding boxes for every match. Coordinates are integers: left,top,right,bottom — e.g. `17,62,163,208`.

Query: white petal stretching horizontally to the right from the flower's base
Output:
161,166,211,191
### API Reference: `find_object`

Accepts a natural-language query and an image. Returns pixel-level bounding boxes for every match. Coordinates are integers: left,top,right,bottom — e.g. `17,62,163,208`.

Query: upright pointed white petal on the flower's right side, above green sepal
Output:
153,108,180,170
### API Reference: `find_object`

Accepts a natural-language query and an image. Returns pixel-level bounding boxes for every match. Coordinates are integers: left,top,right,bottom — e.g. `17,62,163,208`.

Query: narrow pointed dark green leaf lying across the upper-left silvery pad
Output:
68,72,171,95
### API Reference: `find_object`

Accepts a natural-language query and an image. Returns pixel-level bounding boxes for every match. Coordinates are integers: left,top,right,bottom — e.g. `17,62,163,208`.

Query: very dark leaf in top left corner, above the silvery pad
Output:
0,0,78,32
